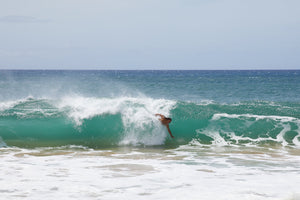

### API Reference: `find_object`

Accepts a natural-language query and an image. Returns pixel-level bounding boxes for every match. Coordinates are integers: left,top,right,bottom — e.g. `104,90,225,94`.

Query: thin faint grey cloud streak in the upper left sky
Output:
0,15,50,23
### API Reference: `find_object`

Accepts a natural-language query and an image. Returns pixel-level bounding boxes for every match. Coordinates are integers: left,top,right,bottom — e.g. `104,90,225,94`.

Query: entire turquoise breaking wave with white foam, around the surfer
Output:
0,96,300,148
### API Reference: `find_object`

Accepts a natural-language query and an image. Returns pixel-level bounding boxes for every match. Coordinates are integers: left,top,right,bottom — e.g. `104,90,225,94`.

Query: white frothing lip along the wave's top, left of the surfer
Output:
57,96,176,125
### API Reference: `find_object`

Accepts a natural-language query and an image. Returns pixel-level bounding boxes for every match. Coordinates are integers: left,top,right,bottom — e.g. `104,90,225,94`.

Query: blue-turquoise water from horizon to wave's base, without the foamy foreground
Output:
0,70,300,148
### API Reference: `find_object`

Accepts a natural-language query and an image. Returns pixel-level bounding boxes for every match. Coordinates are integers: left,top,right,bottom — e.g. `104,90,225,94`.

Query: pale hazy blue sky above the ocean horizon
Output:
0,0,300,70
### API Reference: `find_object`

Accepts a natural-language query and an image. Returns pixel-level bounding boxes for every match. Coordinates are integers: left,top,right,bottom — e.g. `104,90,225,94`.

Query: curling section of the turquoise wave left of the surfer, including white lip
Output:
0,96,174,147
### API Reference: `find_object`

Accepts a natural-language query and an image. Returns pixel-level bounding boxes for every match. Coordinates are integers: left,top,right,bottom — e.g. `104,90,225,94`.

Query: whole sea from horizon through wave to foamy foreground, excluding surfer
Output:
0,70,300,200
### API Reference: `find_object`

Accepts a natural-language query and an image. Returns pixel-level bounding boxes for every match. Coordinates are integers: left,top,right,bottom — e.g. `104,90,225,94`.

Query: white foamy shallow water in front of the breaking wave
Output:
0,146,300,200
